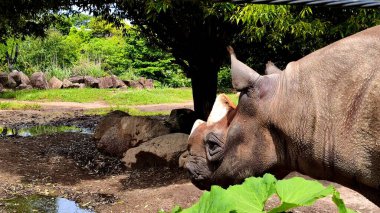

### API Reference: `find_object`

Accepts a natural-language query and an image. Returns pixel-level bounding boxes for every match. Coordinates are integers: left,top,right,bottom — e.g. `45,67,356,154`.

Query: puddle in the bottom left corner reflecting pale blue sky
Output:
0,195,94,213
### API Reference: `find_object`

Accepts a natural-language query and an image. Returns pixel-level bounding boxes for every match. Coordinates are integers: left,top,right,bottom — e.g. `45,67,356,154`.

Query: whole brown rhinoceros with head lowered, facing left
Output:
185,26,380,205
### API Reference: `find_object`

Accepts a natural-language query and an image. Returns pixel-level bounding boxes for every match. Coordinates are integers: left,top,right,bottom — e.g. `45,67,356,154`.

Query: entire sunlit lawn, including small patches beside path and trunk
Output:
0,88,238,115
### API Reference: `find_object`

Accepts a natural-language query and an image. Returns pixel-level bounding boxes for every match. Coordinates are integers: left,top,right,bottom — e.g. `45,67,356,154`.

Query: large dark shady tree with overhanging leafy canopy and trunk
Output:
0,0,379,119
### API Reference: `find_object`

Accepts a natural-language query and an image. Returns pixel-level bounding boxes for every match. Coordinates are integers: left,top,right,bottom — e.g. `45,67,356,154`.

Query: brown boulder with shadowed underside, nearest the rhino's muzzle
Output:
122,133,189,168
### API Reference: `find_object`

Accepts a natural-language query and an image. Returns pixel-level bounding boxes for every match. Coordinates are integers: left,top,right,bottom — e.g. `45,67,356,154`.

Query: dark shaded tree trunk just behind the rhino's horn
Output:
190,61,219,121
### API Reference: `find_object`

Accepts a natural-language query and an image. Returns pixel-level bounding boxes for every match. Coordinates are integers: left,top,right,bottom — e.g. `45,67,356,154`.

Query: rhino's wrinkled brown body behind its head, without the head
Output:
281,26,380,188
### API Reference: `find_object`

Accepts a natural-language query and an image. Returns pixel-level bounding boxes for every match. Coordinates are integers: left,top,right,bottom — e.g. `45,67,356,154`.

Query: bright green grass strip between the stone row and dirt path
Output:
0,88,192,105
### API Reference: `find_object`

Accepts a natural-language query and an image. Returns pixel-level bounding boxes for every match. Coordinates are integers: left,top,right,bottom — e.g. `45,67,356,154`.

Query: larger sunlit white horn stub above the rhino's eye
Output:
207,94,236,125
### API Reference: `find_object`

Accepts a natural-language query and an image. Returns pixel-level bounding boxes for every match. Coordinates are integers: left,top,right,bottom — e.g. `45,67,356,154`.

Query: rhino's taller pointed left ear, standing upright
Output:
227,46,260,91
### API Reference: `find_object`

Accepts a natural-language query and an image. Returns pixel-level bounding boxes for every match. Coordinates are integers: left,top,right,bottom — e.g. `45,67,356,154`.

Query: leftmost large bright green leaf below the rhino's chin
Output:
183,174,277,213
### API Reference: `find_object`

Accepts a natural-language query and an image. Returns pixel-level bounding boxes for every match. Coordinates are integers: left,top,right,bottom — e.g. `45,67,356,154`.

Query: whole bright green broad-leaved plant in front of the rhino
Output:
172,174,354,213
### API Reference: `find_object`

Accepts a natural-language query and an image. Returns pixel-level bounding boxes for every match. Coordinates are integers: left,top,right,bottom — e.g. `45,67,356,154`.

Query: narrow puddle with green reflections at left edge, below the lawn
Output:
0,125,93,137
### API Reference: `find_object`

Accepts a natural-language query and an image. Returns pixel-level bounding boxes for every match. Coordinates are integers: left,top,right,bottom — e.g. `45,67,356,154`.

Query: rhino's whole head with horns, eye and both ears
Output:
185,51,281,189
